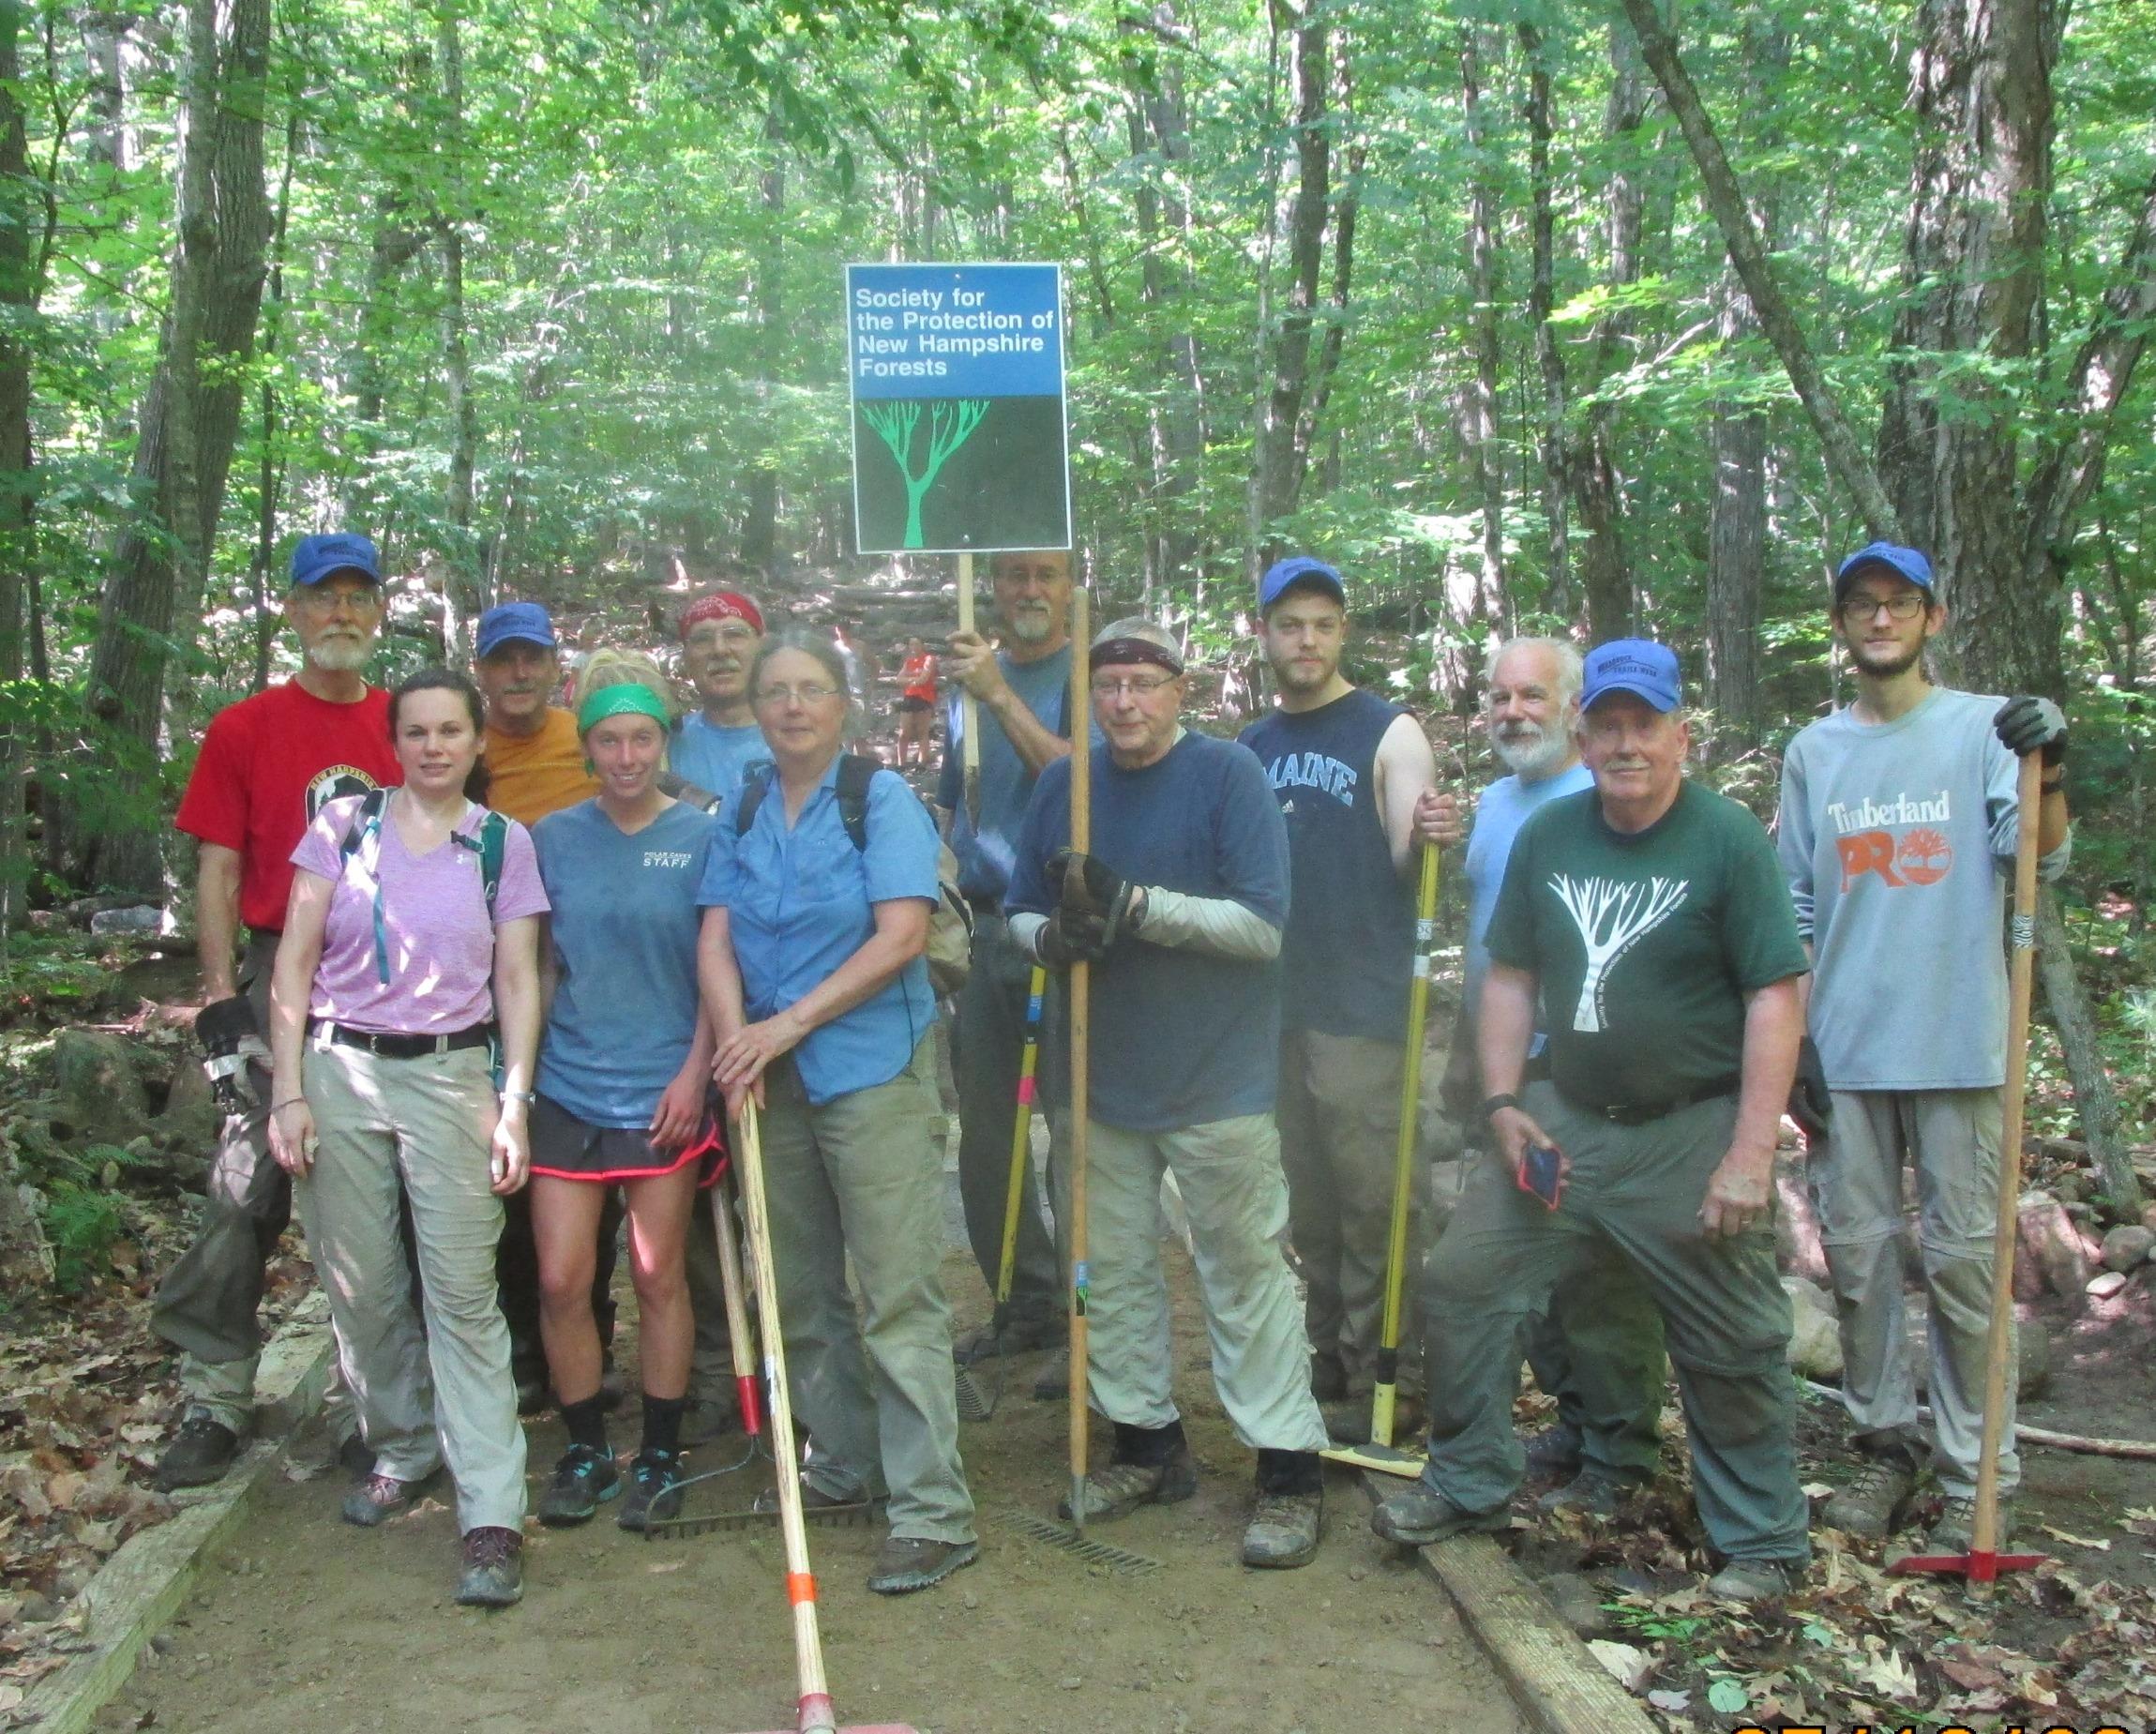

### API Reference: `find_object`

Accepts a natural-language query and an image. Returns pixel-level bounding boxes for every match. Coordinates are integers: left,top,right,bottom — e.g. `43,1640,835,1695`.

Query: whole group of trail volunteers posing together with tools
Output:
156,535,2065,1605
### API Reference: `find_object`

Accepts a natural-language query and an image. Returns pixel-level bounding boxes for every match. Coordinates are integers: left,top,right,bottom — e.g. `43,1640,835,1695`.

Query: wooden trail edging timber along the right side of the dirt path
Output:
1416,1535,1658,1734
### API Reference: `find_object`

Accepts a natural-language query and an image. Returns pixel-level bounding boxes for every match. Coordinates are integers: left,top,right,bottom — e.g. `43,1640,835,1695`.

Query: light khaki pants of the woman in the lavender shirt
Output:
297,1042,524,1530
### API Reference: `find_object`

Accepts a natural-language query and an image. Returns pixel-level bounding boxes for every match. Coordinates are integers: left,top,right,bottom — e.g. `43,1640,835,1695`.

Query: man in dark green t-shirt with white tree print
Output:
1373,639,1809,1603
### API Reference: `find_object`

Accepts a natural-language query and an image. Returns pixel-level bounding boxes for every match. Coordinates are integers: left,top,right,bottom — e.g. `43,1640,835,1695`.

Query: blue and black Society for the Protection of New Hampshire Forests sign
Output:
845,265,1072,554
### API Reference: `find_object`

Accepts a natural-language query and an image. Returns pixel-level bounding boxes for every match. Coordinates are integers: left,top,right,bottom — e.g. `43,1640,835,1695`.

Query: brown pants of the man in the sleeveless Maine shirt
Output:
1276,1029,1429,1397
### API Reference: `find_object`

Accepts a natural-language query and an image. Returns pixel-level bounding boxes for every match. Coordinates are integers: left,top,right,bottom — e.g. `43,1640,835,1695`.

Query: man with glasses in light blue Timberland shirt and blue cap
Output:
1781,541,2070,1553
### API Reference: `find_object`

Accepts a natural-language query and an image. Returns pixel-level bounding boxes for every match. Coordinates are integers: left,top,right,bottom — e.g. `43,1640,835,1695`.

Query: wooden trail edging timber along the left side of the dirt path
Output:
17,1292,332,1734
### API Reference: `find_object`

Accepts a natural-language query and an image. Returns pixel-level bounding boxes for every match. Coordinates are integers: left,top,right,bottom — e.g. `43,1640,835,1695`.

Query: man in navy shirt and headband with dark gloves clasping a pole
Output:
1007,619,1326,1566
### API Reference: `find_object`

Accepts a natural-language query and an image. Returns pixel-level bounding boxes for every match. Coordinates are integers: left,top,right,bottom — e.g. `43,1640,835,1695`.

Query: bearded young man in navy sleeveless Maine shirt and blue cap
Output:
1240,554,1459,1439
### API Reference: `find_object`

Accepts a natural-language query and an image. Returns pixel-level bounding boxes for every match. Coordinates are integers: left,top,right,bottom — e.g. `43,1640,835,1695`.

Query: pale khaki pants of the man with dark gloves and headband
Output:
1064,1113,1330,1452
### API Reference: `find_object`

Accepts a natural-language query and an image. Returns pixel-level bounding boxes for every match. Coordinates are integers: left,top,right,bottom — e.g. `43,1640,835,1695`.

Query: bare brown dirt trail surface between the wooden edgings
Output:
101,1251,1517,1734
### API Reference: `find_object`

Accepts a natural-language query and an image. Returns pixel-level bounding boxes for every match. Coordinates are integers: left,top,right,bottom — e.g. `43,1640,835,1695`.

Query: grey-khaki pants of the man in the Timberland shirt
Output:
1807,1089,2020,1499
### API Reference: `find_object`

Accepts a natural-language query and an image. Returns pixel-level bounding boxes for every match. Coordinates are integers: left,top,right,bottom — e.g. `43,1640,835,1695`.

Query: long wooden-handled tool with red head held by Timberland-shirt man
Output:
1887,753,2043,1596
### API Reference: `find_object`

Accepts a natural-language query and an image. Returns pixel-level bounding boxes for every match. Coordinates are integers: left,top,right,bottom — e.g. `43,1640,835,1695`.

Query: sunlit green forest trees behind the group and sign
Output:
0,0,2156,1212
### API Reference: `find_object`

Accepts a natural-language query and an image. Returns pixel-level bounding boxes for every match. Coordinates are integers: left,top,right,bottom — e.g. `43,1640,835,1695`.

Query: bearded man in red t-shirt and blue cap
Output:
151,535,401,1490
